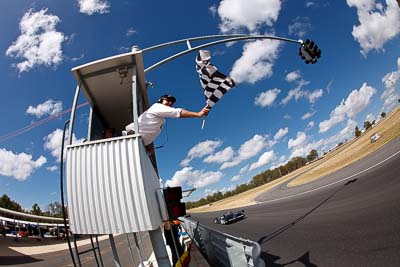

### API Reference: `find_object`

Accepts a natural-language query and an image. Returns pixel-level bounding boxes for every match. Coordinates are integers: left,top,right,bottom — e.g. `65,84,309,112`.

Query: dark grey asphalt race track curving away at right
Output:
192,138,400,266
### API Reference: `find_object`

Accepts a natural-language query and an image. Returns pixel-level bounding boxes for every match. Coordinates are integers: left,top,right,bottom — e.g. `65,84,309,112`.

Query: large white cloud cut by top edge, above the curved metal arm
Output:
218,0,281,33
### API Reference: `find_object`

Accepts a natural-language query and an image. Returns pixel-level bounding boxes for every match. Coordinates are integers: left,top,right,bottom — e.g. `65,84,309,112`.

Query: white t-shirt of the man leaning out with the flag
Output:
125,103,182,146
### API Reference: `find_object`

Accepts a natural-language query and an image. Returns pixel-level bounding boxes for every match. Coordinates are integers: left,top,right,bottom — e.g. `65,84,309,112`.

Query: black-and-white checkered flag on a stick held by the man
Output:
196,50,235,129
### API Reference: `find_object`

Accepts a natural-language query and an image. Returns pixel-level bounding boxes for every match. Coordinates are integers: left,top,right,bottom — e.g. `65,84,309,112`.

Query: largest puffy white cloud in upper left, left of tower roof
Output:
6,9,66,73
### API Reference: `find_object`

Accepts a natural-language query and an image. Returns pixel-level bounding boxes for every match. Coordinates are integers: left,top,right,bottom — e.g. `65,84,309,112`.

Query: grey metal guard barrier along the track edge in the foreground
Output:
180,218,265,267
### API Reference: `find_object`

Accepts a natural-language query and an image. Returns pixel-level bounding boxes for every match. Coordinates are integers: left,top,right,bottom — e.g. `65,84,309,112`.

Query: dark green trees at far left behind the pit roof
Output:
0,194,63,218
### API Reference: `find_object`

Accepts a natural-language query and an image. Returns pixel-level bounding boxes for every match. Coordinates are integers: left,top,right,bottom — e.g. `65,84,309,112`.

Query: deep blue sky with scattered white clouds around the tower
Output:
0,0,400,209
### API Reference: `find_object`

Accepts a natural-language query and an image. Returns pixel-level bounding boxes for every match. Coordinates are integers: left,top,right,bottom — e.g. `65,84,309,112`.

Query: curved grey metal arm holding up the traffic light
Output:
142,34,303,73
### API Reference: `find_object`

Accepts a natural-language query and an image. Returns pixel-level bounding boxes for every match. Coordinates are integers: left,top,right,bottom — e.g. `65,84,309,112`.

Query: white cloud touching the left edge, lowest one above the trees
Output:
0,148,47,181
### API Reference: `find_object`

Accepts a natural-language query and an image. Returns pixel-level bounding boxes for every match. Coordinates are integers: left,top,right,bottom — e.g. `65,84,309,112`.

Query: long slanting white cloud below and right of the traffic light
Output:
319,83,376,133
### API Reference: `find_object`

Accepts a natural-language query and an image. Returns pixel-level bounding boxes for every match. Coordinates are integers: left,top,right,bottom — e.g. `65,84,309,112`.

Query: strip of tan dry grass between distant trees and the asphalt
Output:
189,107,400,213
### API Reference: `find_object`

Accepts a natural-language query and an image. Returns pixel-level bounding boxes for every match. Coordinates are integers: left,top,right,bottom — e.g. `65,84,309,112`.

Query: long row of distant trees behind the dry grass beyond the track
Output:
186,149,318,209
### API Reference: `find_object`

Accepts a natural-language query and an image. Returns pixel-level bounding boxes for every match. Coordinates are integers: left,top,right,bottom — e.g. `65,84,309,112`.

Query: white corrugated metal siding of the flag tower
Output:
66,137,162,234
